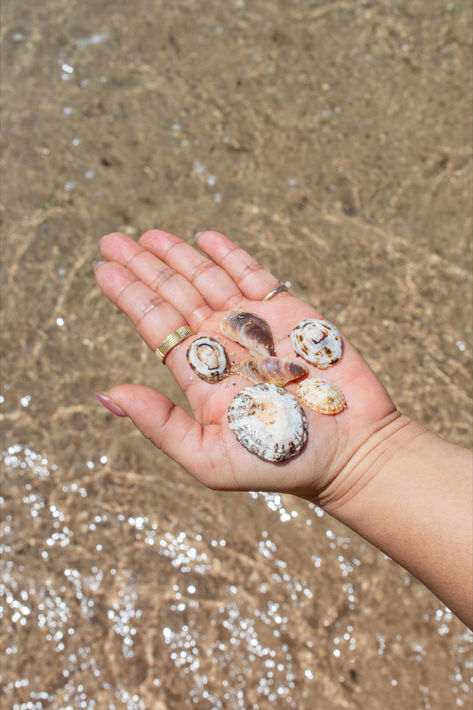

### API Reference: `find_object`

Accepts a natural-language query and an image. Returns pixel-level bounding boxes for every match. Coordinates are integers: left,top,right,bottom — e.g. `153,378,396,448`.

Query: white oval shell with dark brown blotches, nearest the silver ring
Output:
291,318,342,370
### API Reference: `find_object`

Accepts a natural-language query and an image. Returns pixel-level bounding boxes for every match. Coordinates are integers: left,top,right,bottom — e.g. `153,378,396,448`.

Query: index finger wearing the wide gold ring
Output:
95,262,195,391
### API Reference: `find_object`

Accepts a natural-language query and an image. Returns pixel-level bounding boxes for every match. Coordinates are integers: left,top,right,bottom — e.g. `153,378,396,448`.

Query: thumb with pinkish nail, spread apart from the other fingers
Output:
96,385,205,479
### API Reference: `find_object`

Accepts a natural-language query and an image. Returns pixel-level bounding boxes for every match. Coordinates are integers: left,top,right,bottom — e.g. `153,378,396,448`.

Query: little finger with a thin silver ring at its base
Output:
197,232,286,301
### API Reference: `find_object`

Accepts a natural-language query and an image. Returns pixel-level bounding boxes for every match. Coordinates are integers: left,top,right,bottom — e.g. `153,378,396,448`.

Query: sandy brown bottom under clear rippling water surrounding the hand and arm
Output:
0,0,473,710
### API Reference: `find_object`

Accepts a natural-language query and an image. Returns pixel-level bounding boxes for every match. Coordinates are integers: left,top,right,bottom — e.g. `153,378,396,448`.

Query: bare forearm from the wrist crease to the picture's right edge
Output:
321,416,473,626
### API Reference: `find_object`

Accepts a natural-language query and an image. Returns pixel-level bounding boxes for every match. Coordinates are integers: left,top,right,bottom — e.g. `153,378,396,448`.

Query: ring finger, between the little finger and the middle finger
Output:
139,229,242,311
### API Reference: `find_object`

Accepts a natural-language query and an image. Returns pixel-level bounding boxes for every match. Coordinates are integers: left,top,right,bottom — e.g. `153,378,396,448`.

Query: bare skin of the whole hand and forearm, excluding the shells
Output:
95,230,473,626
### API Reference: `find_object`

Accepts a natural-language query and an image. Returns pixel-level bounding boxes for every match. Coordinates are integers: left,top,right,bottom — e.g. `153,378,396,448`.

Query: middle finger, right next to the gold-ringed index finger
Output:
100,233,212,331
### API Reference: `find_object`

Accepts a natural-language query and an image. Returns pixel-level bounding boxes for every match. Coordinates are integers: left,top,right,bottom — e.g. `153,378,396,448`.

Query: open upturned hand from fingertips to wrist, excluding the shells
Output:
96,230,395,498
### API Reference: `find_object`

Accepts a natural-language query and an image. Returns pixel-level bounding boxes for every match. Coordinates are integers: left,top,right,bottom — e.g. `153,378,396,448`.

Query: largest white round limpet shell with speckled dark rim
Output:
228,383,307,461
